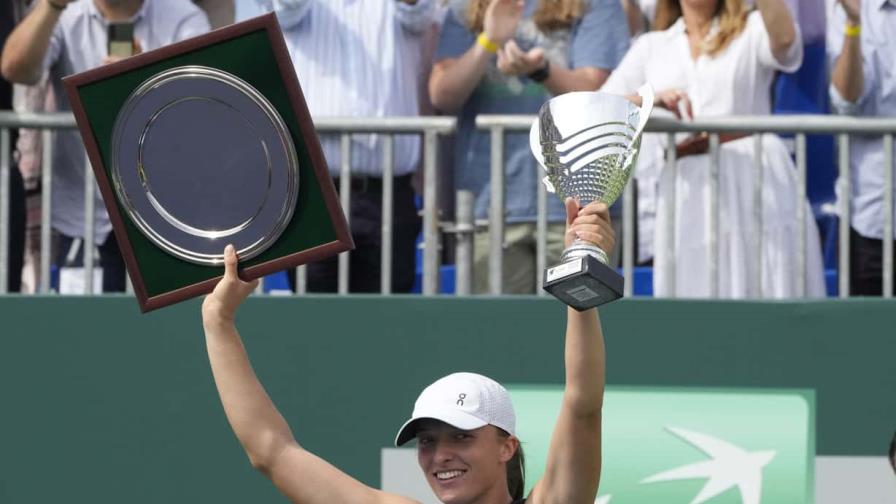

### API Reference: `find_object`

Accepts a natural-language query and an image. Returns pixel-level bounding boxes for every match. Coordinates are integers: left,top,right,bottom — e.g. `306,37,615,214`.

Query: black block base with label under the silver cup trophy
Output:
544,255,624,311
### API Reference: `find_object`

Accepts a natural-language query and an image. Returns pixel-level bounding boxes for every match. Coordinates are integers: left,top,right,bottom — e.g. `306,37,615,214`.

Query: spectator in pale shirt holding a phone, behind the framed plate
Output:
2,0,210,292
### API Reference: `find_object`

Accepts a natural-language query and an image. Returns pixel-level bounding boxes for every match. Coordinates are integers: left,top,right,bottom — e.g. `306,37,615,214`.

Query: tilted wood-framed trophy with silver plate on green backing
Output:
64,14,353,311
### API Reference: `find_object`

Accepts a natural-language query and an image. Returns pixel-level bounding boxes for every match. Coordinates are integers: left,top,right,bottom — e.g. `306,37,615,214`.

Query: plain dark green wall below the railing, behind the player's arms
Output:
0,296,896,504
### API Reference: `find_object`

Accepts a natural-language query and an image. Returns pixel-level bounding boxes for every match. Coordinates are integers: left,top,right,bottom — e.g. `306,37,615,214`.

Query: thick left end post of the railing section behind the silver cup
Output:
488,126,504,295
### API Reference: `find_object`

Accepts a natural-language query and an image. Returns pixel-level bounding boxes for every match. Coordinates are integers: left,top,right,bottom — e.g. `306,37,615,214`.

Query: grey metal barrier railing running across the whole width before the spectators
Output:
0,111,896,297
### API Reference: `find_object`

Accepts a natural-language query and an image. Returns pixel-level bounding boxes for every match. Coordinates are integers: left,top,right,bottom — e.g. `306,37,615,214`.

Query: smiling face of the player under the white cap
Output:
417,420,518,504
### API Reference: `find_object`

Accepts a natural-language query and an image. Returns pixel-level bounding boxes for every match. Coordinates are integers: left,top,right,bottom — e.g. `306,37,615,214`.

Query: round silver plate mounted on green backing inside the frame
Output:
111,66,299,265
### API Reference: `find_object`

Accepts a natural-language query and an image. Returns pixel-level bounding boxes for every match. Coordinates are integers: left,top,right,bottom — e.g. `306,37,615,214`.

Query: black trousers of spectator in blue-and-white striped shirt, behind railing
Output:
288,175,421,293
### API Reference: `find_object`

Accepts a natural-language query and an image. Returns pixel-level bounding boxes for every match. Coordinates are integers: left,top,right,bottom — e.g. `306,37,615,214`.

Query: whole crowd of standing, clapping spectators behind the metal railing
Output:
0,0,896,298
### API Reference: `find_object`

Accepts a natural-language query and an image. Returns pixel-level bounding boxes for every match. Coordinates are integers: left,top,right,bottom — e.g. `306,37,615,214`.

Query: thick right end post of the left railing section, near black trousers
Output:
423,129,440,296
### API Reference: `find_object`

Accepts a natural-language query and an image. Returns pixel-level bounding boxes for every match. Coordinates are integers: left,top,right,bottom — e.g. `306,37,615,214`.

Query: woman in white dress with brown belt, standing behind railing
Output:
601,0,825,298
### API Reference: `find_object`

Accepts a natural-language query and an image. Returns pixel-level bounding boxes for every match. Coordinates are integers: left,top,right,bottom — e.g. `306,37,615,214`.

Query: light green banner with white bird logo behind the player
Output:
509,386,815,504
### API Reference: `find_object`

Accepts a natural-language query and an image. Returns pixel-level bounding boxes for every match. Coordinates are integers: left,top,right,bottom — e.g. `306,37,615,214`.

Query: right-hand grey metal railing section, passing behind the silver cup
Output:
476,115,896,297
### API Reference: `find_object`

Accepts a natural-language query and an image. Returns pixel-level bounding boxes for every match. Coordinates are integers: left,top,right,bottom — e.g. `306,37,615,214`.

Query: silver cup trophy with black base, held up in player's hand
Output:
529,86,653,311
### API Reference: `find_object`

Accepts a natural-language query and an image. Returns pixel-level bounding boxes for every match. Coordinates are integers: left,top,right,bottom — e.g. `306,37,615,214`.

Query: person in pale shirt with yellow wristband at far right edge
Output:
828,0,896,296
